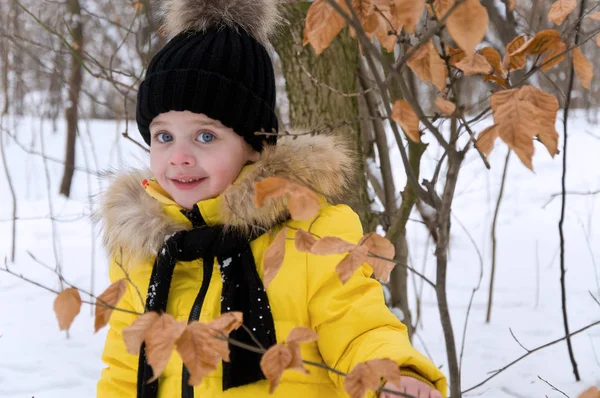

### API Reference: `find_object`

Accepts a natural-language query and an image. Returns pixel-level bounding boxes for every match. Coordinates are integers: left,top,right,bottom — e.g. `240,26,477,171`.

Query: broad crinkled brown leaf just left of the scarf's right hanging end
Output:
176,321,229,386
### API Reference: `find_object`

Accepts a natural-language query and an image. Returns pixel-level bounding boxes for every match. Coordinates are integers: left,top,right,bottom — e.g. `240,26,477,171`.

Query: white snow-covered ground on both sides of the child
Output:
0,113,600,398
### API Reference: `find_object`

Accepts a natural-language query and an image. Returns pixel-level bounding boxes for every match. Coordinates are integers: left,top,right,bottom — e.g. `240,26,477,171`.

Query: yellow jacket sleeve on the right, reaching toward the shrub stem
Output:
306,205,447,396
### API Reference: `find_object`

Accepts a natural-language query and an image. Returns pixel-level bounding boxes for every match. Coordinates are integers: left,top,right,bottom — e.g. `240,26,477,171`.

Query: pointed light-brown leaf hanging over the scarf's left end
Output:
144,313,186,382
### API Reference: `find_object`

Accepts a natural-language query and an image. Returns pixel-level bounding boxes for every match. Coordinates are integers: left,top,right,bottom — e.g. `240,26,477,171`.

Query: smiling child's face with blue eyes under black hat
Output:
150,111,259,209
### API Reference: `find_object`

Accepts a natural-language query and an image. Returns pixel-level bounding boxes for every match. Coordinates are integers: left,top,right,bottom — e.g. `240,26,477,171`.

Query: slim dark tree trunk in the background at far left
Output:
60,0,83,197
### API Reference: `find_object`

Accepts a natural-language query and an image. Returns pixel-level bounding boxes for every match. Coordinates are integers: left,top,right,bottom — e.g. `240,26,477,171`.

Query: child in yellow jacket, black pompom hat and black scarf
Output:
98,0,446,398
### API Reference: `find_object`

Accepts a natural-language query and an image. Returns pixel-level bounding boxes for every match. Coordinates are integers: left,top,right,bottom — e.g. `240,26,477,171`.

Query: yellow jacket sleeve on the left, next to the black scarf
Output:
96,261,138,398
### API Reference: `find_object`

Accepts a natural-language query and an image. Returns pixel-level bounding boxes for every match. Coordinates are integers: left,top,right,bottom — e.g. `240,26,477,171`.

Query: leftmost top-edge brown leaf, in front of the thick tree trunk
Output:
302,0,346,55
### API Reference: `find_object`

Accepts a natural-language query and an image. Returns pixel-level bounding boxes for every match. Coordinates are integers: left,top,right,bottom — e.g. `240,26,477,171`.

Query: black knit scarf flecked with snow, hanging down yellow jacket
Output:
137,206,277,398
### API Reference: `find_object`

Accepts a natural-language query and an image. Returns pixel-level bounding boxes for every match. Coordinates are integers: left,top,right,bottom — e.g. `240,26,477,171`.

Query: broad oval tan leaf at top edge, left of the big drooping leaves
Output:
446,0,489,54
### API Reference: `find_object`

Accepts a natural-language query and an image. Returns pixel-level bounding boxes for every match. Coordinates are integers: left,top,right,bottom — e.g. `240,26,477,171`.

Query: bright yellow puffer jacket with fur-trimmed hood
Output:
97,136,447,398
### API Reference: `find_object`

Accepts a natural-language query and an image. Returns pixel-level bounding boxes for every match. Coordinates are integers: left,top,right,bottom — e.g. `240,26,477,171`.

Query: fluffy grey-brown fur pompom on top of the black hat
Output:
161,0,281,47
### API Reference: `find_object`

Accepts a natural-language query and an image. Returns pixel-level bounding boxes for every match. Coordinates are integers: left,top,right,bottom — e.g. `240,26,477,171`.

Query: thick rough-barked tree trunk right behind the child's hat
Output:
273,2,376,231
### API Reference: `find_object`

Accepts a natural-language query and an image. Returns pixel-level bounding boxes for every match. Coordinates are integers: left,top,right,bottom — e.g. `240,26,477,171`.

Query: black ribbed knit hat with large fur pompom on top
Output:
136,0,279,152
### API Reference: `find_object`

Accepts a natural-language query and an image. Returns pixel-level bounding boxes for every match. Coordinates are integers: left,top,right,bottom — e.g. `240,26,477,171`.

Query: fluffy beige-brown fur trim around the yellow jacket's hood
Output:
93,133,356,263
